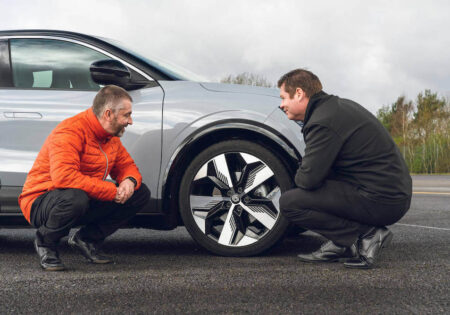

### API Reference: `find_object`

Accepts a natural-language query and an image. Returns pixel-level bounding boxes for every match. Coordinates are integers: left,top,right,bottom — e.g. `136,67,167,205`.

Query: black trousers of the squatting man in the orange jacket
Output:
31,183,150,247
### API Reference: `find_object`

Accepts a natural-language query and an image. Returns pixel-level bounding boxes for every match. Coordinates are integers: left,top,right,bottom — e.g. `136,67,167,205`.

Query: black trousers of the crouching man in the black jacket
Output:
280,180,411,246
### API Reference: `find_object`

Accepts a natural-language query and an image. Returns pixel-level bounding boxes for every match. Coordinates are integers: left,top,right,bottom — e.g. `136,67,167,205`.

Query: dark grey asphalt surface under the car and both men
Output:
0,176,450,314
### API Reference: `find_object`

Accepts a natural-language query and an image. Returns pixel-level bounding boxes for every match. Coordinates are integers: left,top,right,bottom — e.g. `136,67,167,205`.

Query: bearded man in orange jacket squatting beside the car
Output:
19,85,150,271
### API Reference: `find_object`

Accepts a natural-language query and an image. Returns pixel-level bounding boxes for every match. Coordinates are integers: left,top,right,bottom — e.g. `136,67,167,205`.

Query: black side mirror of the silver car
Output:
89,59,131,88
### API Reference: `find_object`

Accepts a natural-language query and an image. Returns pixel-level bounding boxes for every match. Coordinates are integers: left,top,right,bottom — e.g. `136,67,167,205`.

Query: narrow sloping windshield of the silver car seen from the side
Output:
100,37,209,82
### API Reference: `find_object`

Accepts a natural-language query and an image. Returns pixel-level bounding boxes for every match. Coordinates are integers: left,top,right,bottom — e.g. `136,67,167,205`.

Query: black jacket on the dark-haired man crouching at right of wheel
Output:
295,92,412,202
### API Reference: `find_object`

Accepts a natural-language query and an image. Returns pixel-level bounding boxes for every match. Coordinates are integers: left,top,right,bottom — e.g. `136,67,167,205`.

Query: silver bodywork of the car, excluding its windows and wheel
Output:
0,31,304,256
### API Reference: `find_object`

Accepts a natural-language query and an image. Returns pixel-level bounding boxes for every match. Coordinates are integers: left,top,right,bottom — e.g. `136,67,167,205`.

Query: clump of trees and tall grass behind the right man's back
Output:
377,90,450,173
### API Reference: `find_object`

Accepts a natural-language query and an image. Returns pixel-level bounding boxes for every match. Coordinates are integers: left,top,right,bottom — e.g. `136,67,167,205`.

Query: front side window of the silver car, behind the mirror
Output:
10,39,111,91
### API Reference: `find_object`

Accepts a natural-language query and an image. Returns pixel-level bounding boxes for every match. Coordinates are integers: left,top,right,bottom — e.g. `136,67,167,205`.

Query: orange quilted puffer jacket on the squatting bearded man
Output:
19,108,142,222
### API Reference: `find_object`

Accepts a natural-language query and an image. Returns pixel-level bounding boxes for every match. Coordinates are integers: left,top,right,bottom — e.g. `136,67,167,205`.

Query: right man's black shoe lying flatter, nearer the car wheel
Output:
297,241,358,262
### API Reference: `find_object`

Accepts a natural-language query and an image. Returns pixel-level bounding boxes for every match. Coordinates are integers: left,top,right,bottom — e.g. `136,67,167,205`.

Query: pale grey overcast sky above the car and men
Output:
0,0,450,113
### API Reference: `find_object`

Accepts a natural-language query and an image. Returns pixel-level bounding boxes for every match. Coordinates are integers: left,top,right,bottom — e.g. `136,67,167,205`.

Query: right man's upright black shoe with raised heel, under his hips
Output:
344,227,394,269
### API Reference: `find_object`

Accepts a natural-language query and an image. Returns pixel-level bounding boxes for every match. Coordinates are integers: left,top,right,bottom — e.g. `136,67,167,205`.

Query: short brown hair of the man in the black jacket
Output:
278,69,322,97
